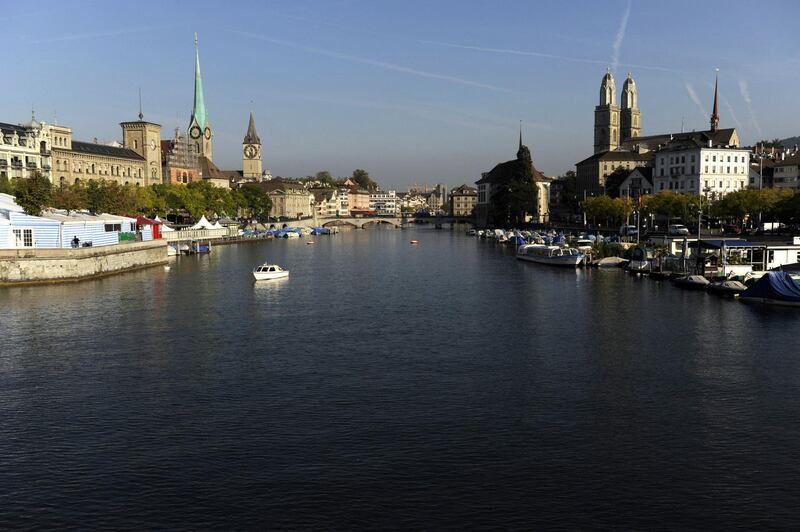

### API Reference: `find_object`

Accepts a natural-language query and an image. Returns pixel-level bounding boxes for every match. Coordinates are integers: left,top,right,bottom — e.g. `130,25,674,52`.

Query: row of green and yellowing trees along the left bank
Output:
0,174,272,222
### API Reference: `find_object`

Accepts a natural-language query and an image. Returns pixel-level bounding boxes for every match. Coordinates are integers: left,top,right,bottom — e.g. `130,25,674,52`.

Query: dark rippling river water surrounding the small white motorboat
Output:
0,229,800,530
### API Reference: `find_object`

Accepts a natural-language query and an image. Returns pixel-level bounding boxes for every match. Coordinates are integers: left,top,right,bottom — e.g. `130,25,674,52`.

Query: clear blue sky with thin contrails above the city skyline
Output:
6,0,800,190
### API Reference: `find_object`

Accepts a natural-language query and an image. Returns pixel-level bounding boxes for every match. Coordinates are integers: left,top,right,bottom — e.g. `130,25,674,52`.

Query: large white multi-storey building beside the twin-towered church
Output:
653,137,750,198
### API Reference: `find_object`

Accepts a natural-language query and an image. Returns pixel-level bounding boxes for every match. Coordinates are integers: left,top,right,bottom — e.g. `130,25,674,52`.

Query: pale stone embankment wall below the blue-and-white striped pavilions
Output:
0,240,167,285
